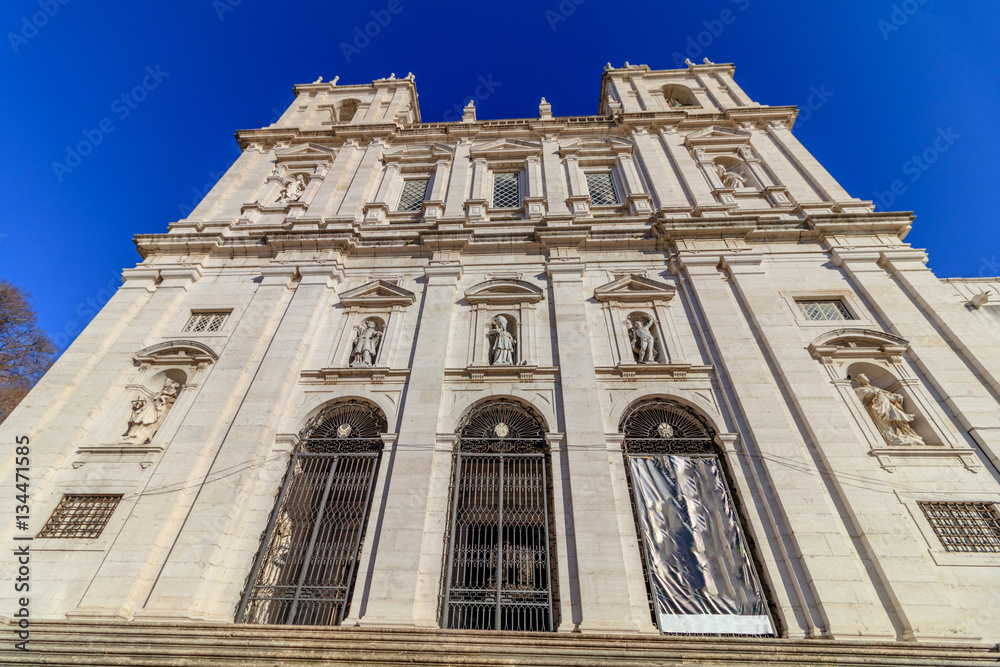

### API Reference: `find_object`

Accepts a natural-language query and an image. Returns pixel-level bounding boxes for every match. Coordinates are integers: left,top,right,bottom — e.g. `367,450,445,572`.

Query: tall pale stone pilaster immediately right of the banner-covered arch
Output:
679,251,897,639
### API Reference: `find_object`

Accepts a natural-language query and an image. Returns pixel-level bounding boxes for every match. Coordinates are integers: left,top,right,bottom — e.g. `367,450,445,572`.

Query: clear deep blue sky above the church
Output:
0,0,1000,347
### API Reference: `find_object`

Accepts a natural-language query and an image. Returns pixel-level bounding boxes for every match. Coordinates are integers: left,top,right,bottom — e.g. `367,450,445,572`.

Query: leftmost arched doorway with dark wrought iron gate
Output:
236,401,386,625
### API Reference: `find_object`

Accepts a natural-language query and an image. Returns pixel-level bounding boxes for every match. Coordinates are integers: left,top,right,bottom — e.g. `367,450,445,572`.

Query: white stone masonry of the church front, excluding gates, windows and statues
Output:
0,64,1000,664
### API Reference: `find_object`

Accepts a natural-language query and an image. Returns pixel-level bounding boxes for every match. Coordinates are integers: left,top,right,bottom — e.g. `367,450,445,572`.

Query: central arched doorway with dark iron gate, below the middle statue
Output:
442,399,555,631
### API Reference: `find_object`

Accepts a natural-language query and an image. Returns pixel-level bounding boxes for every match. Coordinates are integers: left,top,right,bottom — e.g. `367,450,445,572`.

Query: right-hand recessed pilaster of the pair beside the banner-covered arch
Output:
723,254,978,641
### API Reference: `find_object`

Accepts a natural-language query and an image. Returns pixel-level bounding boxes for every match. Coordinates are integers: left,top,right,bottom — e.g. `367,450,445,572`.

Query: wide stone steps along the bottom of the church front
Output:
0,621,1000,667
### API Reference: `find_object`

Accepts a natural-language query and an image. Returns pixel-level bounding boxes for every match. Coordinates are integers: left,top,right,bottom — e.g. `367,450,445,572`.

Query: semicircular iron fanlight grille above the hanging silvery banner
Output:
619,401,717,456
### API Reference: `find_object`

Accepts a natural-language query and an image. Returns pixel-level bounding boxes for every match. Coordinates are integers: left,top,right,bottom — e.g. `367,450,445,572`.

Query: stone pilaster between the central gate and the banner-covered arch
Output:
546,238,649,633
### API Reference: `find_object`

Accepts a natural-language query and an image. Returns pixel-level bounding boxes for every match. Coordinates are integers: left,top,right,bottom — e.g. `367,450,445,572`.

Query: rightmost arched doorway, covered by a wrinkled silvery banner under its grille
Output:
620,400,774,635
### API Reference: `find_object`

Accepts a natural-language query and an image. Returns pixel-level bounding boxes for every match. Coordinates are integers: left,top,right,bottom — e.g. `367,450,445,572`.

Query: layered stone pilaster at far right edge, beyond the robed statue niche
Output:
832,247,1000,468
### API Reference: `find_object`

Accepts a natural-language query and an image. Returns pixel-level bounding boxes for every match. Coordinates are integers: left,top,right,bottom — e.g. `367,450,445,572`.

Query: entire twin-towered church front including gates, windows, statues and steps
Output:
0,62,1000,664
